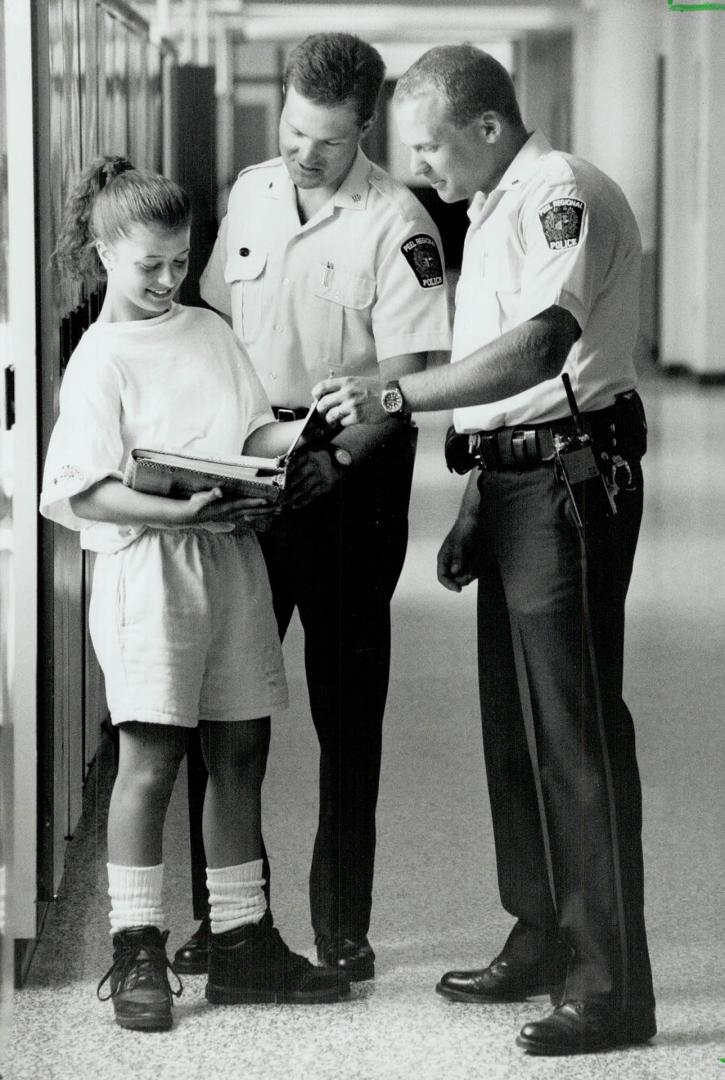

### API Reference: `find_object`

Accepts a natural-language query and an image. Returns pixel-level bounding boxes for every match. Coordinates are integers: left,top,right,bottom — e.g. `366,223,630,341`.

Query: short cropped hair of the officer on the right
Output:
393,45,523,127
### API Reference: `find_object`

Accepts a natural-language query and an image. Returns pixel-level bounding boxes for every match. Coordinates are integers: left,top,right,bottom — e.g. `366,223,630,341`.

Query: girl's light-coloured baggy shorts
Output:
89,529,287,728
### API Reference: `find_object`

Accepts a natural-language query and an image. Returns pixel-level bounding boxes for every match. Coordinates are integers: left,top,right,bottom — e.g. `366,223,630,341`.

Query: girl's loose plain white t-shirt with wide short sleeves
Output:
40,303,274,552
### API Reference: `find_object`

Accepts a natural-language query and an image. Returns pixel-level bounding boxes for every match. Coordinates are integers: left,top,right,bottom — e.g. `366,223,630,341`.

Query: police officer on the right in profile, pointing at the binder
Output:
315,46,656,1054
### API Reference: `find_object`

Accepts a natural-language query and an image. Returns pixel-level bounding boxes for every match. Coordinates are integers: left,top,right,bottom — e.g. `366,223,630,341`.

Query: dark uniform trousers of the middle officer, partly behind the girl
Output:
184,423,417,941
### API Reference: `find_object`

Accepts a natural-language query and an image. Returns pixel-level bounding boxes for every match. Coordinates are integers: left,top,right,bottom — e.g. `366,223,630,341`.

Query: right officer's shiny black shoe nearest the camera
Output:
516,1001,657,1055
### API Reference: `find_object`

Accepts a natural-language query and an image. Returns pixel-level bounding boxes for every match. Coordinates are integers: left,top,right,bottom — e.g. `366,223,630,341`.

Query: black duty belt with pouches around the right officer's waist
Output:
459,391,647,470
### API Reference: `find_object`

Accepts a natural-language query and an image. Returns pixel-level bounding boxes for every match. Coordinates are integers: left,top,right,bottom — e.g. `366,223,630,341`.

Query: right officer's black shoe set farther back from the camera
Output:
435,959,565,1004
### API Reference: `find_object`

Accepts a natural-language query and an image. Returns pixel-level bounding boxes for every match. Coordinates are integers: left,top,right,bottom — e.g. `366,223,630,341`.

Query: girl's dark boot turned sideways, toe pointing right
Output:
206,912,350,1005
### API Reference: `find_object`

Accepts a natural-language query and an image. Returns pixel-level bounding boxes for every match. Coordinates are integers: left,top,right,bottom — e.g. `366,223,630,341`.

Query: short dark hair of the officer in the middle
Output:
284,33,385,125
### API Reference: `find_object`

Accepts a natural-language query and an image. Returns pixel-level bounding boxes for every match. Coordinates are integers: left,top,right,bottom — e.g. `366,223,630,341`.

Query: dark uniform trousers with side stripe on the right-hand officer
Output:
478,461,654,1018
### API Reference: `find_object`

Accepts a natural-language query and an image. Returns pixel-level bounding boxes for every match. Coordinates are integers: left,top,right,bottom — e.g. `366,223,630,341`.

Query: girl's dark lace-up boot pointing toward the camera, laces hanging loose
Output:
96,927,183,1031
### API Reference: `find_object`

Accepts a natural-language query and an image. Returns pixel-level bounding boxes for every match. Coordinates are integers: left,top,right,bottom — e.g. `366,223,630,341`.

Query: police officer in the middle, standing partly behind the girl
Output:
176,35,451,980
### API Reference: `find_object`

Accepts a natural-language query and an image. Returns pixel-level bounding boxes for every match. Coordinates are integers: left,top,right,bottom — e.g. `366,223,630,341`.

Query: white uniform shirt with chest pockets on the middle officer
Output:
195,150,451,406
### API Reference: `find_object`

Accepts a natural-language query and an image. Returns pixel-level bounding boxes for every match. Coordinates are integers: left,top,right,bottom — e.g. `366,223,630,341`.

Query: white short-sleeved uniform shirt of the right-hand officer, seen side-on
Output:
452,132,642,432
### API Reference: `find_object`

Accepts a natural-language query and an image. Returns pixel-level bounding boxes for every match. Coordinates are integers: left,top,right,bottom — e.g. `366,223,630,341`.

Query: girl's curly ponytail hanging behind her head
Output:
53,156,134,288
